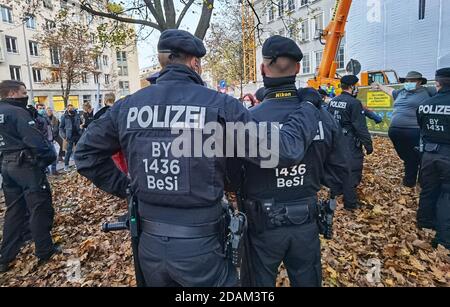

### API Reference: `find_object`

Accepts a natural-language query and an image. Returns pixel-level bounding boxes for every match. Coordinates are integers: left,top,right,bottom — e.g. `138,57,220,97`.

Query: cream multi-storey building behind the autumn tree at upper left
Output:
0,0,140,111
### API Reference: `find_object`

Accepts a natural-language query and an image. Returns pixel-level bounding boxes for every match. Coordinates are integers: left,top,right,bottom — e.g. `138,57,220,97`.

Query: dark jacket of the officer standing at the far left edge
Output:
0,99,56,167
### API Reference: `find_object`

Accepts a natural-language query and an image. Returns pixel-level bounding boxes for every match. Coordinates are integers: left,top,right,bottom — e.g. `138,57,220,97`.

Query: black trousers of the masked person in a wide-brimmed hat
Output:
389,127,420,187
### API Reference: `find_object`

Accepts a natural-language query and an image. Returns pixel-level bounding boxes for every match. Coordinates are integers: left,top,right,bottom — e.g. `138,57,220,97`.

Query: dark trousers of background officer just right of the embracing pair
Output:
343,134,364,209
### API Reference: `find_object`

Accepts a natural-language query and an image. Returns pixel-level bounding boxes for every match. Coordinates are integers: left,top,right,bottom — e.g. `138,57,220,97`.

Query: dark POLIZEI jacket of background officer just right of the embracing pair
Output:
328,92,372,148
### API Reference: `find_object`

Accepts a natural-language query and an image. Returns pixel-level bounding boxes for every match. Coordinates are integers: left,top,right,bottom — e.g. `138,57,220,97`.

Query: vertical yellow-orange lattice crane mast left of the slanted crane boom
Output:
242,0,256,83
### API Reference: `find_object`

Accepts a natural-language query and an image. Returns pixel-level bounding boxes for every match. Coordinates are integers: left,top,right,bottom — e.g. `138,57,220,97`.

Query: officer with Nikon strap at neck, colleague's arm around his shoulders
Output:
229,35,348,287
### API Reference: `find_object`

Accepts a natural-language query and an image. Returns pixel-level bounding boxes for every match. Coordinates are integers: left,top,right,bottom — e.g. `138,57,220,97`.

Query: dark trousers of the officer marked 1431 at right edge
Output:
417,150,450,248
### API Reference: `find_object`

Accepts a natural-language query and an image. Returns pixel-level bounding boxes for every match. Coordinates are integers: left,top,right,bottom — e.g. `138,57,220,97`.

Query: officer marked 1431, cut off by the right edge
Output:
417,68,450,249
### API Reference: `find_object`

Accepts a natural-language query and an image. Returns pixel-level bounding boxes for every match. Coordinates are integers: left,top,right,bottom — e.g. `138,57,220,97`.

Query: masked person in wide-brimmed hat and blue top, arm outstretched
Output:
372,71,436,188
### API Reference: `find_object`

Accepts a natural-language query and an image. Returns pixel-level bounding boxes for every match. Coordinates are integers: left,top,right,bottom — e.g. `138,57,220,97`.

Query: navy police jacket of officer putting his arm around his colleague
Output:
75,65,318,223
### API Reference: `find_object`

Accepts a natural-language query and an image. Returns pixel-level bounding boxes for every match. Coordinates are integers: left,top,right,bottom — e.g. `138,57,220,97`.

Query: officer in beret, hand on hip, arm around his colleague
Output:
75,30,318,287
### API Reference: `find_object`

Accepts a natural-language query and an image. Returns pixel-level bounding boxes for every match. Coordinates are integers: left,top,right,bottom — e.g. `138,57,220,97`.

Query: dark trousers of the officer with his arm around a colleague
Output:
139,233,238,287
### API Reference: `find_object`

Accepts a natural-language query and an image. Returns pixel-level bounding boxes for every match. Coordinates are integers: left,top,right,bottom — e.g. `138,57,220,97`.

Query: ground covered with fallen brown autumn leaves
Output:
0,138,450,287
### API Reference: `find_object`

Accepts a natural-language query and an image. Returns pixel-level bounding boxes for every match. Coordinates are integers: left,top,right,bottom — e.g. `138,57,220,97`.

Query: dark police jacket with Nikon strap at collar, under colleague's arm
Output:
229,85,349,203
